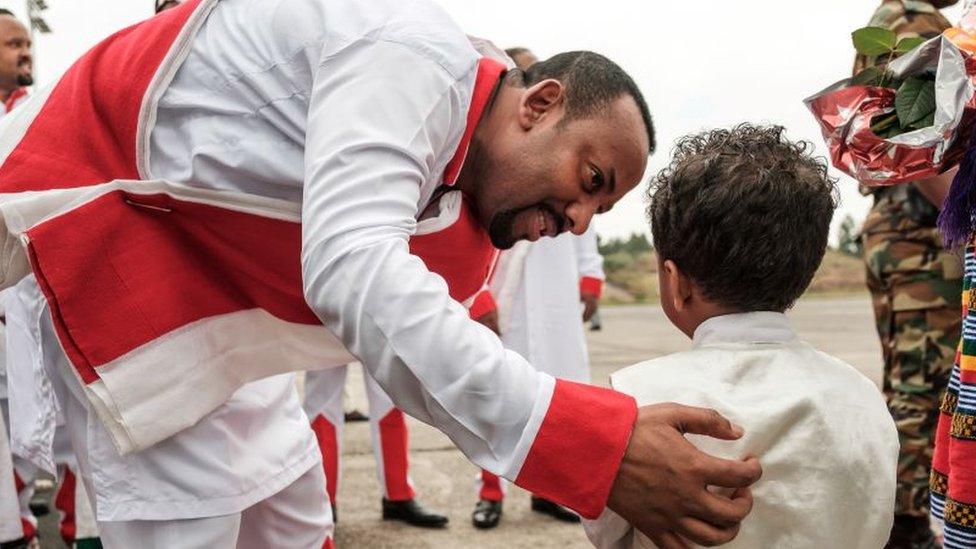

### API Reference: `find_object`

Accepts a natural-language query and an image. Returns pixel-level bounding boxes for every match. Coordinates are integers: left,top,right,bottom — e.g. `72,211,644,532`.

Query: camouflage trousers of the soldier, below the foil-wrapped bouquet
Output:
863,229,962,516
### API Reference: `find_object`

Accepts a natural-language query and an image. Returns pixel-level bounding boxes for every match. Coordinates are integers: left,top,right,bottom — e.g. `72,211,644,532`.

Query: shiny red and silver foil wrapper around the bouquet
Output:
805,36,976,186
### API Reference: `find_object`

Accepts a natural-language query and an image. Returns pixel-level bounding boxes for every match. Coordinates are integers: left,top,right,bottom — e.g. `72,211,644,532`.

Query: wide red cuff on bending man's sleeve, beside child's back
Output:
515,379,637,519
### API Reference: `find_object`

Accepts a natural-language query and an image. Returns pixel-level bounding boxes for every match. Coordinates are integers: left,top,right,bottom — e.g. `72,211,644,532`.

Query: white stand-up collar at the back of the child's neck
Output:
692,311,797,348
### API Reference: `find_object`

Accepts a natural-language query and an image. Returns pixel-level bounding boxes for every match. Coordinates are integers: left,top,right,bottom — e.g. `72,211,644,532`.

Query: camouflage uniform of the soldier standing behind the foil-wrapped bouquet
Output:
855,0,962,523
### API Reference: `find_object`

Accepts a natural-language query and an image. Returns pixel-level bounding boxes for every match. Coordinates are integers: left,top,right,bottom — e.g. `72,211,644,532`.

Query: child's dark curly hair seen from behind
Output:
648,124,837,312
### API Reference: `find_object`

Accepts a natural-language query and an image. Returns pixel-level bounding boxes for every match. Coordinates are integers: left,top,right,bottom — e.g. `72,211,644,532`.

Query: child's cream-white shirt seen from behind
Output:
584,312,898,549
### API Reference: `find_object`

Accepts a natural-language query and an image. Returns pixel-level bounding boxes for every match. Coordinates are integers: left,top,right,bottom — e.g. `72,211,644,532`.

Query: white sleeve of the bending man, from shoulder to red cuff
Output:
302,40,555,478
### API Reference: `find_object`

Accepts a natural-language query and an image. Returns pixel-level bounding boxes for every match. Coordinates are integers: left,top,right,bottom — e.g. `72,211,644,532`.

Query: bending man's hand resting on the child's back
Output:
607,404,762,549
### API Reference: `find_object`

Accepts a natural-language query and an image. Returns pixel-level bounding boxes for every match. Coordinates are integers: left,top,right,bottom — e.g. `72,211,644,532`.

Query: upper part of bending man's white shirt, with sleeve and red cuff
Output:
0,0,636,516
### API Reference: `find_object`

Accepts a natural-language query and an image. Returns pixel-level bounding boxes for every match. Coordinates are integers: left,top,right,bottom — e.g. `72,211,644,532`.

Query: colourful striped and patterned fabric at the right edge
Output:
929,245,976,549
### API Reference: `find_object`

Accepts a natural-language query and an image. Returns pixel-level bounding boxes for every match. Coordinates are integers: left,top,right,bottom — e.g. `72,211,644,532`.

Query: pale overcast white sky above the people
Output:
0,0,961,241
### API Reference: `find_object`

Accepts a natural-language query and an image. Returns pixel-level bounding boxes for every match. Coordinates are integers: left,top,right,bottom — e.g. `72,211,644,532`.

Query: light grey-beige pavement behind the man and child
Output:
36,295,881,549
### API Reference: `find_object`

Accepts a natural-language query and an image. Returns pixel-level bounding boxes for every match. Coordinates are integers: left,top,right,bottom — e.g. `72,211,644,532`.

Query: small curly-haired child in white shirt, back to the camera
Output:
586,125,898,549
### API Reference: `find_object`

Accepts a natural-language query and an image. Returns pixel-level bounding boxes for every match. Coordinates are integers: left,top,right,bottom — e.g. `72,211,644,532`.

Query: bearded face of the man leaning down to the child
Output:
475,87,649,249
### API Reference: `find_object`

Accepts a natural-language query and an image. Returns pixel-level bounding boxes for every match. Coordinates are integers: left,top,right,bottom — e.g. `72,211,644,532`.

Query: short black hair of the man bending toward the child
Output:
509,51,657,153
